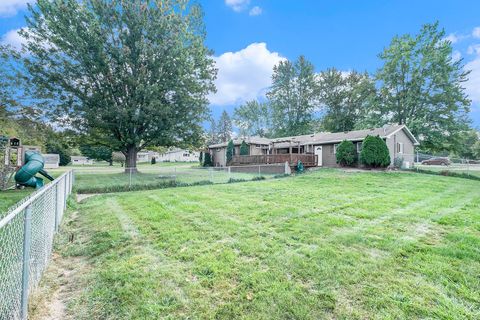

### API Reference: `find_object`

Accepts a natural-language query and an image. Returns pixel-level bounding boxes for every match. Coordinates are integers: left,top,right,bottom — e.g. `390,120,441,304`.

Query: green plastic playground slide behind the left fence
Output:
15,151,53,189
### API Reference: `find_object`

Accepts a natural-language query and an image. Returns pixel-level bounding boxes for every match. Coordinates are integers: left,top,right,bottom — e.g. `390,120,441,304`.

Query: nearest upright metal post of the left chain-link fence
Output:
21,205,32,320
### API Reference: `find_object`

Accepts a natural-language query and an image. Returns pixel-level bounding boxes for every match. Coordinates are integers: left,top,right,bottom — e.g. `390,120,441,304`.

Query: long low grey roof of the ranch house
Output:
210,125,419,148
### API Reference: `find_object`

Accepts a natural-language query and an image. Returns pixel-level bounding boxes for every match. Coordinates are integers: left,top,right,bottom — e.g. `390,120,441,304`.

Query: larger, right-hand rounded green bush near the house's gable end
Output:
360,136,390,168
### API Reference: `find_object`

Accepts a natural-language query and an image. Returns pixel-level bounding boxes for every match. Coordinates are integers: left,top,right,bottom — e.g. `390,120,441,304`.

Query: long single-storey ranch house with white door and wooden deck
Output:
208,125,419,167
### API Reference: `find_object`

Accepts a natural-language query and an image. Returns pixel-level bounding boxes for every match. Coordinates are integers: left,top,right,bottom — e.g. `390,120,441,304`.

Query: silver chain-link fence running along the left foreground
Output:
0,171,74,319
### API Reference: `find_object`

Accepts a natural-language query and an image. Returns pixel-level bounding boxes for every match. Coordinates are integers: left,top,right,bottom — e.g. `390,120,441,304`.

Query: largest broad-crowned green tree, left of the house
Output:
23,0,216,172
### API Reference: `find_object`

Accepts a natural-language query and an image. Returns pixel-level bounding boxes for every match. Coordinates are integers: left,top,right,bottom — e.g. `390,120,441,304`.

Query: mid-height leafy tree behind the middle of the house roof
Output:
318,68,376,132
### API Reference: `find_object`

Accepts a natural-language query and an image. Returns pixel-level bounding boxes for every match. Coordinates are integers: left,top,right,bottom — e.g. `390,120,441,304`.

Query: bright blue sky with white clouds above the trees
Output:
0,0,480,128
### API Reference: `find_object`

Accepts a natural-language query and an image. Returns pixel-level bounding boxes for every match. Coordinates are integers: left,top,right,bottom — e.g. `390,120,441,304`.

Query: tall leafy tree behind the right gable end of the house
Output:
367,23,470,152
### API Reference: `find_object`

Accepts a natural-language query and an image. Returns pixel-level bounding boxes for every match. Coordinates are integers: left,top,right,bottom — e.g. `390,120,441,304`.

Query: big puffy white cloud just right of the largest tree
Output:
209,43,285,105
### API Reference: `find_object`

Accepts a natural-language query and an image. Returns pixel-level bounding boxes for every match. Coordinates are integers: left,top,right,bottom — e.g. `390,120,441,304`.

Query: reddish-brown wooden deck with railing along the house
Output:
230,153,318,167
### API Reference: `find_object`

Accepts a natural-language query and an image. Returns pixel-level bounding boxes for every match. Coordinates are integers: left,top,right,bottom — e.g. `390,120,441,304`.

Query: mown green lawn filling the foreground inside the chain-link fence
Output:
42,170,480,319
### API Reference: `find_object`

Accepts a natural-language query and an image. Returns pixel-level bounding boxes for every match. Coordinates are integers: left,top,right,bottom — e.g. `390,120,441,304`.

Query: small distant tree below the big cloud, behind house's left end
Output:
233,100,272,137
